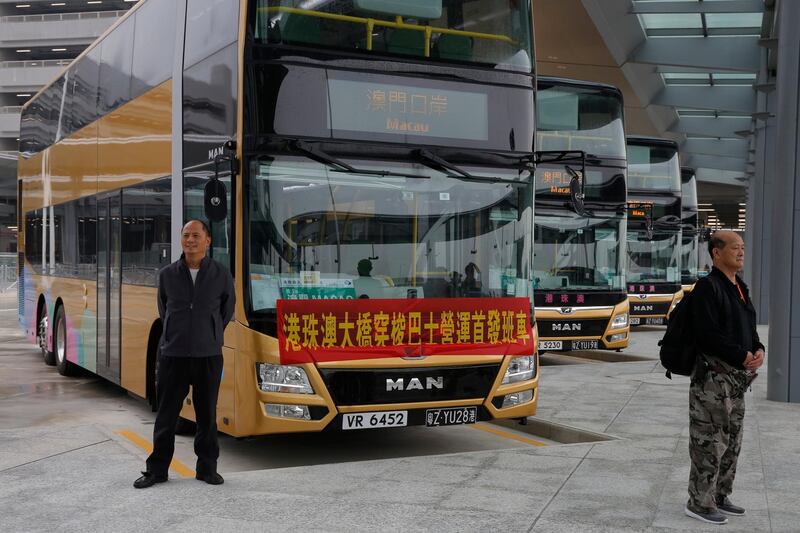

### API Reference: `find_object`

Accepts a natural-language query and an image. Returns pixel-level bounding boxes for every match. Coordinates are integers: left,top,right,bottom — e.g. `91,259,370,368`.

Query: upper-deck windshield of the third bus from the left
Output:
628,144,681,193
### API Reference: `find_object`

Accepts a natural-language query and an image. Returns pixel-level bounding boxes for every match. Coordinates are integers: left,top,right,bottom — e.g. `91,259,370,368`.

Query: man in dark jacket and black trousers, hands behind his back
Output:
133,220,236,489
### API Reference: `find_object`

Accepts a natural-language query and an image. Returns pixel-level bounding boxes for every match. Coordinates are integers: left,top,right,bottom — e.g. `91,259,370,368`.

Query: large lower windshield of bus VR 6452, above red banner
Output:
248,156,533,312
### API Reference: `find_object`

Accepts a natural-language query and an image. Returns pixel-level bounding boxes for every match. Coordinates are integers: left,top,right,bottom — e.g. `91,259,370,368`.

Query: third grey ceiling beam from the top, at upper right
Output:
650,85,756,115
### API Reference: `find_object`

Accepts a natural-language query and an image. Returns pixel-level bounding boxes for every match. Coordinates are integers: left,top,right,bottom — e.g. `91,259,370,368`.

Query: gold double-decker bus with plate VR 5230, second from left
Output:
534,76,630,351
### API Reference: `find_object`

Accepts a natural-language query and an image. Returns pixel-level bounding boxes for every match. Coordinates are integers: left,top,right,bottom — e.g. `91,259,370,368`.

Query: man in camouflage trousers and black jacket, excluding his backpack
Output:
686,231,765,524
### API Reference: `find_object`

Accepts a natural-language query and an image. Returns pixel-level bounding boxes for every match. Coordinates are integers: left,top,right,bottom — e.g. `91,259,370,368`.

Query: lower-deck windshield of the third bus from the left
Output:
627,228,681,283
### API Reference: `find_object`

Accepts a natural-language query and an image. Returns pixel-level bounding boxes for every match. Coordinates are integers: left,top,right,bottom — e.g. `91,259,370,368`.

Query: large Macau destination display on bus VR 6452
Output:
328,79,489,141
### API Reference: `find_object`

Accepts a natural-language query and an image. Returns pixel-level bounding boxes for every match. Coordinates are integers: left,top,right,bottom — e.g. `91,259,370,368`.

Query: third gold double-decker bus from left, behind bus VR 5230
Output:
626,137,683,326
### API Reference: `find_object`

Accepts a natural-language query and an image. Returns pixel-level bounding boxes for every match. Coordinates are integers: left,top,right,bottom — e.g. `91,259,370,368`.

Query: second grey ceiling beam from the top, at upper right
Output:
628,36,761,72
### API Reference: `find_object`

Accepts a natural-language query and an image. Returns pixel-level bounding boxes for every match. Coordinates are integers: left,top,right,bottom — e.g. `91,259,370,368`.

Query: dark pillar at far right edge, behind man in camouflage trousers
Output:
767,0,800,403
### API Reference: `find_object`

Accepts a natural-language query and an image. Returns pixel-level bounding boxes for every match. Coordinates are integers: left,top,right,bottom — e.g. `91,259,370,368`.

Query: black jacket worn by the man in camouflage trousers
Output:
692,267,764,369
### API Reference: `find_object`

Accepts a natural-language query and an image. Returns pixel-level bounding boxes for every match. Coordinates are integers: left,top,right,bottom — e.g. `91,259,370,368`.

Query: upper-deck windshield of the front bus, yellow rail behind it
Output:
251,0,533,72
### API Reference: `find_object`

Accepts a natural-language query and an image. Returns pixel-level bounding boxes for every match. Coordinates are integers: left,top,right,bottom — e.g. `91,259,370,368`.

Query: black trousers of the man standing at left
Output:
147,355,222,477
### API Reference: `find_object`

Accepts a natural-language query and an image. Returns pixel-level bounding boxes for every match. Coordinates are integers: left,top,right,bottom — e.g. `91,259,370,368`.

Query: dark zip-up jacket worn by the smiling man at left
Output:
158,254,236,357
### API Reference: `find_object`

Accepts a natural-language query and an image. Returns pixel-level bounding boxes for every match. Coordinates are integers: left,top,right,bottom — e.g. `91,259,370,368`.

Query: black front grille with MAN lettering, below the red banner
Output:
320,364,500,405
